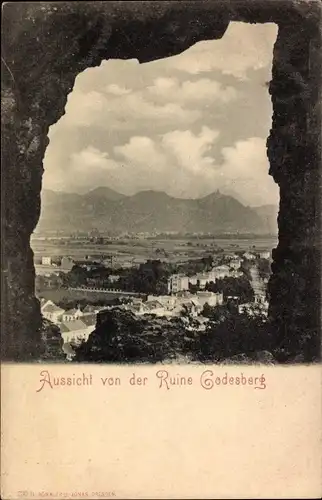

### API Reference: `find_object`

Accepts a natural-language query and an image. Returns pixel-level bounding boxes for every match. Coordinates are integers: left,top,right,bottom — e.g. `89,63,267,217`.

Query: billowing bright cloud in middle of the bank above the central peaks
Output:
100,127,219,197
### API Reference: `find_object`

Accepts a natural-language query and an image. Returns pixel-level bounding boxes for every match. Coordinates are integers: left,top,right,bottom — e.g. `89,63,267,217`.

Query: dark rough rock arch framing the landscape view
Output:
1,0,322,362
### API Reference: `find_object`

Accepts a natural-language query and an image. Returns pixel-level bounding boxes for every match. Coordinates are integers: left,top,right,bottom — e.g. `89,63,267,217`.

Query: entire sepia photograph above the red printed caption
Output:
3,2,320,364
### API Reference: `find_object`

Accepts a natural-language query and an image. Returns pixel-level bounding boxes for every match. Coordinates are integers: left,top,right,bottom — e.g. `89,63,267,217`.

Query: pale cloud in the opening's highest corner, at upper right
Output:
166,22,277,79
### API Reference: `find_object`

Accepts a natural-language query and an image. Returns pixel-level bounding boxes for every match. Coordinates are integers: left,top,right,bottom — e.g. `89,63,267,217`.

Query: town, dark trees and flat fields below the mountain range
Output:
32,226,276,362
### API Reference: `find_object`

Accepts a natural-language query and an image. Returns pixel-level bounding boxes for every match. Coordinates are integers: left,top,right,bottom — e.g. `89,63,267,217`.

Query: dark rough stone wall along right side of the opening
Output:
267,8,322,361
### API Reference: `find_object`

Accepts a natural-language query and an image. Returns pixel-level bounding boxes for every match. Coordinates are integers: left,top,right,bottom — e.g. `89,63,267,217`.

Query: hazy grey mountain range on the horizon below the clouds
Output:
37,187,278,234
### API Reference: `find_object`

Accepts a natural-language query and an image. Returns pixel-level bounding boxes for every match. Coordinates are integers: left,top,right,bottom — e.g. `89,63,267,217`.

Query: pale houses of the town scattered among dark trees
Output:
41,252,270,354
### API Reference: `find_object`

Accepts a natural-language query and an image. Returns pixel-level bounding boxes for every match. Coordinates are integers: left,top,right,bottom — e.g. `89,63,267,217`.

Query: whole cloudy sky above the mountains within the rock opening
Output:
43,22,279,206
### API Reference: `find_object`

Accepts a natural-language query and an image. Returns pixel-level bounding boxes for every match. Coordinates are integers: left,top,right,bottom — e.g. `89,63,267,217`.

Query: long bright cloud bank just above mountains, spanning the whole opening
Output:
44,130,278,206
